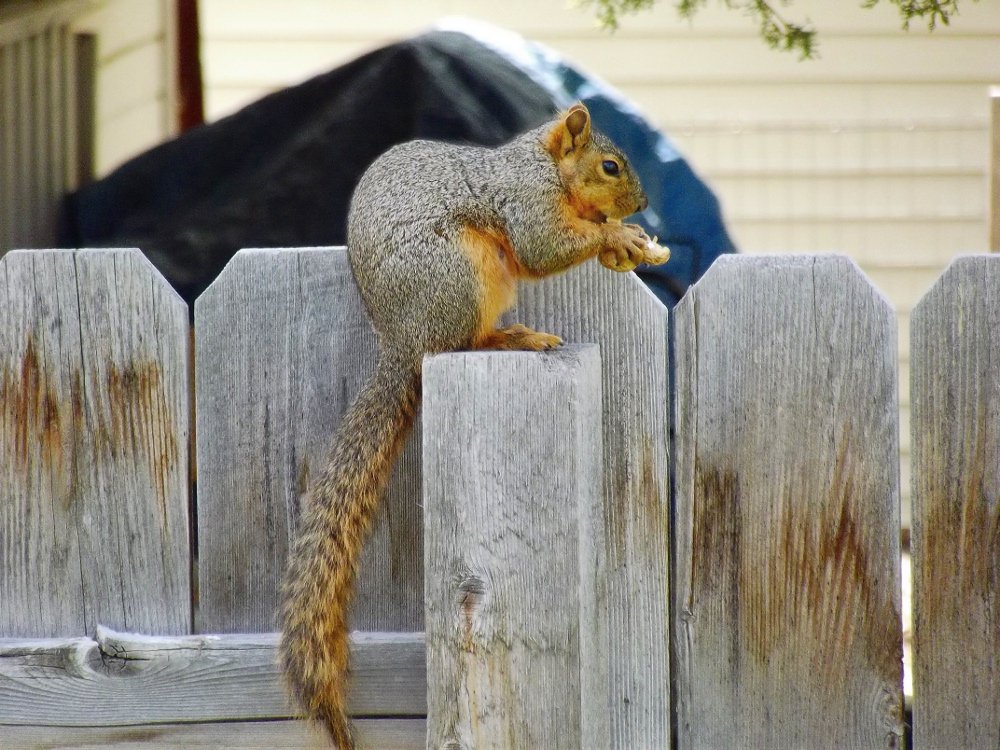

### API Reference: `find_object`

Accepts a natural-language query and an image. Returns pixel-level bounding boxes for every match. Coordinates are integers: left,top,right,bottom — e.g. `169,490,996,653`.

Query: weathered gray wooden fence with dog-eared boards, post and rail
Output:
0,248,1000,750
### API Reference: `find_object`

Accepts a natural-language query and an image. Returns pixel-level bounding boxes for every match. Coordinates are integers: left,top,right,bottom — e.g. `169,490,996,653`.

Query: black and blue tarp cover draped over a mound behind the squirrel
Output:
60,24,733,304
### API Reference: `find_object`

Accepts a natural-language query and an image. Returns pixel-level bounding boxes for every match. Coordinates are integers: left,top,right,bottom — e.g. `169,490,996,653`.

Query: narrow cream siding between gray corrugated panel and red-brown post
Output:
74,0,176,177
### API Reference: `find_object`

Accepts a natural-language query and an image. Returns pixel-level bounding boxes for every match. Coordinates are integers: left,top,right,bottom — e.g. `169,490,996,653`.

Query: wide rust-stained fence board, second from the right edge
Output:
674,256,903,750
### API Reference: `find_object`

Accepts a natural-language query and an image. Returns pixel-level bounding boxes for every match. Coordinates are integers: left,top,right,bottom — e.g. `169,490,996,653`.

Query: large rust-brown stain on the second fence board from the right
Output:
691,439,902,686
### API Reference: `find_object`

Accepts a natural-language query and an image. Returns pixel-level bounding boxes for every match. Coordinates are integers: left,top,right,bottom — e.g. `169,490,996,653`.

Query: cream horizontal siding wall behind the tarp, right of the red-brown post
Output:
201,0,1000,515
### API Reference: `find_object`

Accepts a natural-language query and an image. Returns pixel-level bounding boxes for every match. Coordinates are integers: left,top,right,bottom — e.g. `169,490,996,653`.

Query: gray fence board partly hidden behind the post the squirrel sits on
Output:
507,263,670,750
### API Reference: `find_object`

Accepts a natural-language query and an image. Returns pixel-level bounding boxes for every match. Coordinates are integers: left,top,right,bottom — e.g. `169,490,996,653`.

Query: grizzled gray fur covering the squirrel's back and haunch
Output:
348,122,639,362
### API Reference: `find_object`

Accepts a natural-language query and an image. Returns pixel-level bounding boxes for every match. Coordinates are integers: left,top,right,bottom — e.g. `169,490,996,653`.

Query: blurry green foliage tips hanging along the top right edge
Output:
582,0,979,59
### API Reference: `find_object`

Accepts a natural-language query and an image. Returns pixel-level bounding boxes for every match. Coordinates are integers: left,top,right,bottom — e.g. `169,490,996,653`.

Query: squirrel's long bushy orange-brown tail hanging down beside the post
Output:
281,357,420,750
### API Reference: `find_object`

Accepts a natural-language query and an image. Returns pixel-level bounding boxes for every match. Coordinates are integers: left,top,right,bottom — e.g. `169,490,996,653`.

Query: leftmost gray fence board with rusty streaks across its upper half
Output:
0,250,191,637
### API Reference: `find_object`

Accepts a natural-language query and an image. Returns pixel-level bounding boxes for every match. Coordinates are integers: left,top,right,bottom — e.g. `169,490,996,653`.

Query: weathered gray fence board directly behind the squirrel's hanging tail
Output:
195,248,423,633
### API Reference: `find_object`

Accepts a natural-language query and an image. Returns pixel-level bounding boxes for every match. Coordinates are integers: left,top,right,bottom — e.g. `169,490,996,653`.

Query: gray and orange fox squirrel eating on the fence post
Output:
281,104,670,750
